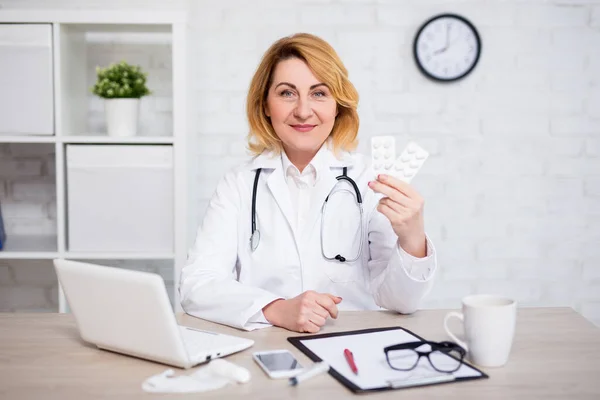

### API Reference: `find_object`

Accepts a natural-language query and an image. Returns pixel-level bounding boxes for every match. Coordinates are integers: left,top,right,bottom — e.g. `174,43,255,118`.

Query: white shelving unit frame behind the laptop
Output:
0,10,192,312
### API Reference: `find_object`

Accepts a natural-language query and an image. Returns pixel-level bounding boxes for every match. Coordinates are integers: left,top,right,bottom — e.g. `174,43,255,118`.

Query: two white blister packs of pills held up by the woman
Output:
371,136,429,183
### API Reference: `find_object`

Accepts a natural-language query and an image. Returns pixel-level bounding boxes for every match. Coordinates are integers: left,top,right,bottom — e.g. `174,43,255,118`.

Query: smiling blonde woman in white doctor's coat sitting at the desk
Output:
180,34,436,332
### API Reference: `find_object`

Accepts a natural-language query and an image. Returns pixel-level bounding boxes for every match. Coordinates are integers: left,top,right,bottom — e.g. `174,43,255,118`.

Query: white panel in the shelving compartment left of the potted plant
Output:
0,24,54,135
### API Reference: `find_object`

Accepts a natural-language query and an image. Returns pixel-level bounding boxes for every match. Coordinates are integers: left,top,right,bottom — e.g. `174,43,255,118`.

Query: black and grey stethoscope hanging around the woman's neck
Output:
250,167,364,262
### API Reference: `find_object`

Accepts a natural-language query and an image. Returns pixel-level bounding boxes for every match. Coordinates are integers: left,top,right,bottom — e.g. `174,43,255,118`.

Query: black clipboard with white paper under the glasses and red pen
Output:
288,326,489,393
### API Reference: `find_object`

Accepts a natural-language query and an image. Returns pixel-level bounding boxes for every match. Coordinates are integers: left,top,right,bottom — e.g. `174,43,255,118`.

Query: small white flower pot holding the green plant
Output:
104,99,140,137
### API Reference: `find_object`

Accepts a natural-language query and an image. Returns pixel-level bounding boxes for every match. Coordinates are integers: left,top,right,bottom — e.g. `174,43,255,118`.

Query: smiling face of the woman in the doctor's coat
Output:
266,58,337,157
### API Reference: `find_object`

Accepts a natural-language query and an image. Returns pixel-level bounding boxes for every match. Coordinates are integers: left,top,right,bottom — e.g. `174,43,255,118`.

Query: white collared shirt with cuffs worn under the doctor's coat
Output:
249,146,434,324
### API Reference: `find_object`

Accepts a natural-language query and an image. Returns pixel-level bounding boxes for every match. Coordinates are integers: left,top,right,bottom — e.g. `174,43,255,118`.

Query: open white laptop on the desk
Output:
54,259,254,368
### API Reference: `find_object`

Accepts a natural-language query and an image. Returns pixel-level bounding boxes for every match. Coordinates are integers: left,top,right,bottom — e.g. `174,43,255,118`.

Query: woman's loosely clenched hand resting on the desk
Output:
263,290,342,333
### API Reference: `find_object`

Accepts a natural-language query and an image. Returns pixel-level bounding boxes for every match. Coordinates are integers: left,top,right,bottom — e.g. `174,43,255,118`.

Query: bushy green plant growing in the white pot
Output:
91,61,151,99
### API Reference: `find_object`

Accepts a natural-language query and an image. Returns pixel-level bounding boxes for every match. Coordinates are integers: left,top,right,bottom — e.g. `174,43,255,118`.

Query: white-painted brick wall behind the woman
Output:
0,0,600,324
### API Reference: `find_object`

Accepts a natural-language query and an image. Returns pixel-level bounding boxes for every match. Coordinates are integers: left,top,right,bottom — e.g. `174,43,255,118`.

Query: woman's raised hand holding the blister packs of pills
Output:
369,174,427,257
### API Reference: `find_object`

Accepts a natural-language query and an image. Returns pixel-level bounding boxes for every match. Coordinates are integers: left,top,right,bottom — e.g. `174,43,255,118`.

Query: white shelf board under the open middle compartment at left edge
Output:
0,235,58,259
